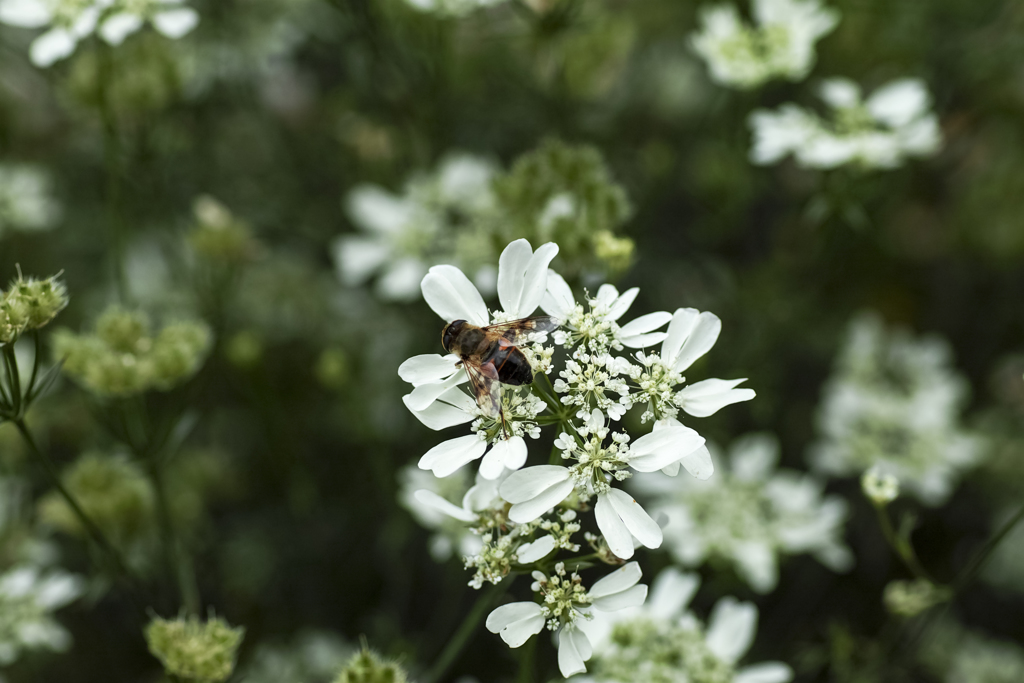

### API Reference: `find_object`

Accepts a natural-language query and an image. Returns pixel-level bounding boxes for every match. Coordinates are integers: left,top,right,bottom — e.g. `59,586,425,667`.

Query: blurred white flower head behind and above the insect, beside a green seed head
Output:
334,154,497,301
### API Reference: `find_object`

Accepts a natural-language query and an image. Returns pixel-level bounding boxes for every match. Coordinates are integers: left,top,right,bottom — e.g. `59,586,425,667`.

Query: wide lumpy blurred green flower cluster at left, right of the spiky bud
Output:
53,306,210,396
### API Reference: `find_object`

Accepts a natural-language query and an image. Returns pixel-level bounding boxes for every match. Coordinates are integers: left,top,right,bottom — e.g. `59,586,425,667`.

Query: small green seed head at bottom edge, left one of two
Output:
145,616,245,683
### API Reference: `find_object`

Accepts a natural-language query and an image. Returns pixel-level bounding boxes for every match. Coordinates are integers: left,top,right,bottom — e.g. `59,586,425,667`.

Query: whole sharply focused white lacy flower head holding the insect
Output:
398,240,754,676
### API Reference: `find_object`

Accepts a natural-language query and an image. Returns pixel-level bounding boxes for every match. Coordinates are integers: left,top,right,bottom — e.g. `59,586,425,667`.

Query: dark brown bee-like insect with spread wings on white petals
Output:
441,315,558,422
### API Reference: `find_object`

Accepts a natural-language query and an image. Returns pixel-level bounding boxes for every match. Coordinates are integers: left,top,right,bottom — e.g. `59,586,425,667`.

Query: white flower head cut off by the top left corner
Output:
0,0,199,67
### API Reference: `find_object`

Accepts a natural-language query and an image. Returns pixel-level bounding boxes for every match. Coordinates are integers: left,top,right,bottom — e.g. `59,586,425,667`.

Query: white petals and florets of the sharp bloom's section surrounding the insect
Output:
398,240,558,479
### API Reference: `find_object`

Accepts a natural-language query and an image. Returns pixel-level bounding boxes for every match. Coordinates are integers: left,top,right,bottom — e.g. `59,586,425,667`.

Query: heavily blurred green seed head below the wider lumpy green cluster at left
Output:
39,453,154,545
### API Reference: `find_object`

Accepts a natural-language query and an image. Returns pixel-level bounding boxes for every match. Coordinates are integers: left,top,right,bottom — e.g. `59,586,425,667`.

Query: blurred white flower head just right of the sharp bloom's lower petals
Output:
635,434,853,593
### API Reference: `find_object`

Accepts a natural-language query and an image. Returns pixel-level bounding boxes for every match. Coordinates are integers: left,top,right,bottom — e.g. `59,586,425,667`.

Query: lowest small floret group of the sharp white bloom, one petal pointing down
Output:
486,562,647,678
